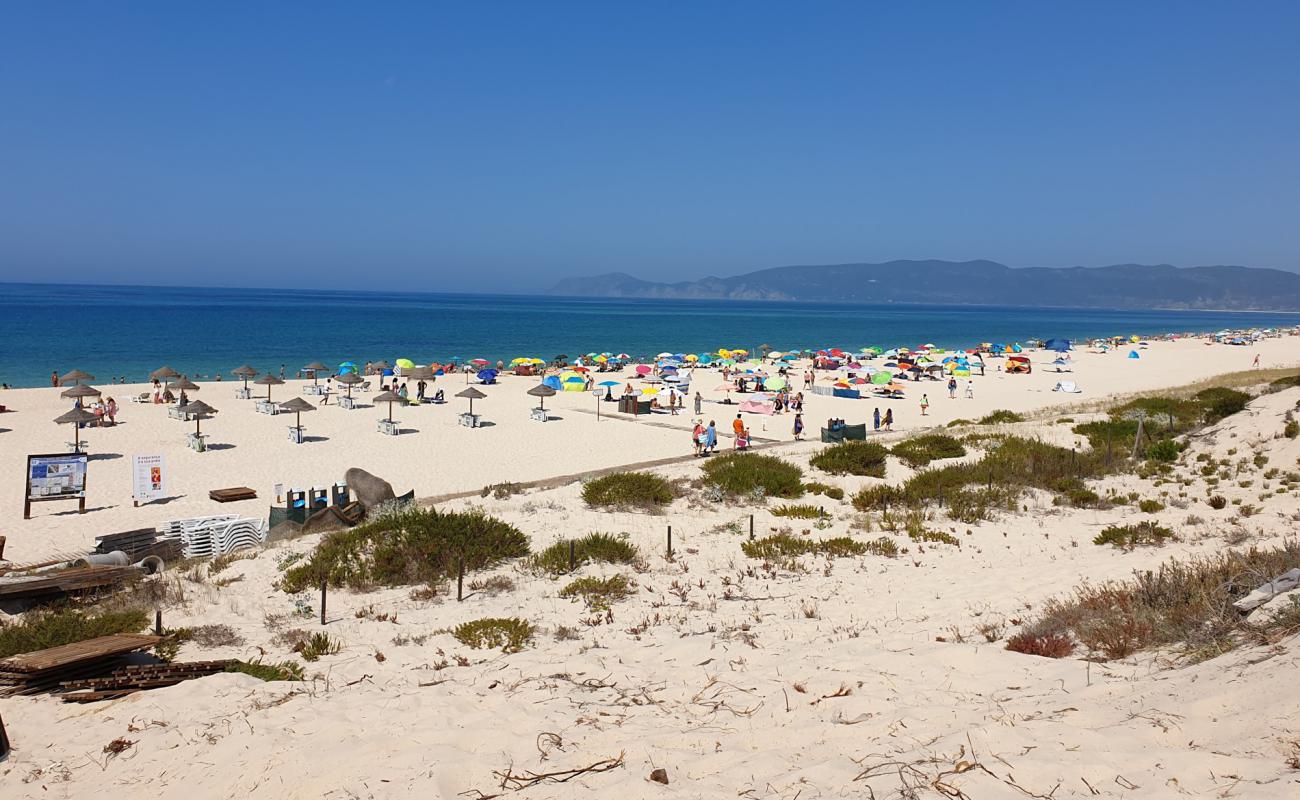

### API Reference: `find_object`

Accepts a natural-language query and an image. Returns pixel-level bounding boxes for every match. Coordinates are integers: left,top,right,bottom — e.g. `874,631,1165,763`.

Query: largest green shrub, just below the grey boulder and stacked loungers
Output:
280,506,528,593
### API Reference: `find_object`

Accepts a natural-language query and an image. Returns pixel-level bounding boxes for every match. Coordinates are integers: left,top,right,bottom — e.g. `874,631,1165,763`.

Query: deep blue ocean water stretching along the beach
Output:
0,284,1300,386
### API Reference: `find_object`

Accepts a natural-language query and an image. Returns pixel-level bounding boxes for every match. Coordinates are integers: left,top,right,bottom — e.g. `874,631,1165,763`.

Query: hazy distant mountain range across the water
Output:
551,260,1300,311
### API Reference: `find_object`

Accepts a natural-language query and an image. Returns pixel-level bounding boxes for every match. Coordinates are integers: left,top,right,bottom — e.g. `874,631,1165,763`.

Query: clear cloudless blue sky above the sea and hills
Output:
0,0,1300,291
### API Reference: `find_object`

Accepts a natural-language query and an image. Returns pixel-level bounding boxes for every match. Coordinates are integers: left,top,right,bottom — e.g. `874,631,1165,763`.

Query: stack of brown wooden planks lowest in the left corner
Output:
0,633,163,697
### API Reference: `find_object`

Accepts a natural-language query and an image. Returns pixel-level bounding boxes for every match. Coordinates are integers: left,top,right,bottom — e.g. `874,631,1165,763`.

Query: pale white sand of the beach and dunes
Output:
0,337,1300,800
